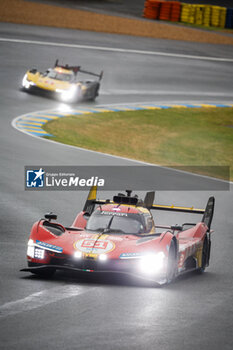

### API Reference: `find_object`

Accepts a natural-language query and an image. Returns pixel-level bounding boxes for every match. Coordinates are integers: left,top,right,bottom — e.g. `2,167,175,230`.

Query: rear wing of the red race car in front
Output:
83,186,215,229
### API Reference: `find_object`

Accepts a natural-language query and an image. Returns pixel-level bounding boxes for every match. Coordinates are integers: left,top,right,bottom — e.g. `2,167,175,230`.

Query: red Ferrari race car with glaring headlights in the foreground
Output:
21,187,215,284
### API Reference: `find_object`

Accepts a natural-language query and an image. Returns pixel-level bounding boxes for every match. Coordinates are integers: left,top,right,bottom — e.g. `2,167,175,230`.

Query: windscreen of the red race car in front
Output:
86,210,145,234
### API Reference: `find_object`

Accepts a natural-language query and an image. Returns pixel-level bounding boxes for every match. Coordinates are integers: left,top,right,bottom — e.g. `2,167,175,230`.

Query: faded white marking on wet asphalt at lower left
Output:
0,285,93,319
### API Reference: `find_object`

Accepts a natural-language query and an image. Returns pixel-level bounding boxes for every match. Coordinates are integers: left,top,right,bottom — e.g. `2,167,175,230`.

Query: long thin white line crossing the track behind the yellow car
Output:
0,38,233,62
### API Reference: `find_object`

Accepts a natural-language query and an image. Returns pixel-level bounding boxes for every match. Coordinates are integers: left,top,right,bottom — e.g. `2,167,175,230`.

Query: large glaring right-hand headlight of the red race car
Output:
139,252,165,275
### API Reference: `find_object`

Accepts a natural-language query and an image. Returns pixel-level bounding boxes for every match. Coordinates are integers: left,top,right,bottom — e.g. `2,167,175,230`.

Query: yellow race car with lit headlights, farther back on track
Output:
22,60,103,102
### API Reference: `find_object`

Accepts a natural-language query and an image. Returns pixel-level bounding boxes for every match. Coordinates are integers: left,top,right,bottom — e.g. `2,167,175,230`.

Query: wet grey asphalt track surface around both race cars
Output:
0,24,233,350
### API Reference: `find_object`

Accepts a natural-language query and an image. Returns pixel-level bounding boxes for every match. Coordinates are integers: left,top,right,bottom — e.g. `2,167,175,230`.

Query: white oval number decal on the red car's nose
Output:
74,238,115,254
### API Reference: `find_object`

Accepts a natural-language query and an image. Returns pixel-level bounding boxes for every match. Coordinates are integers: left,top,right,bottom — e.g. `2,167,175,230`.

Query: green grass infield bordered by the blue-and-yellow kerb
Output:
44,108,233,179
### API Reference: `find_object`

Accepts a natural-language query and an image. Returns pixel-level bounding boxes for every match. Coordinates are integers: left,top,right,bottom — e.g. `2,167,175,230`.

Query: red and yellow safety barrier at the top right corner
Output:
143,0,233,28
